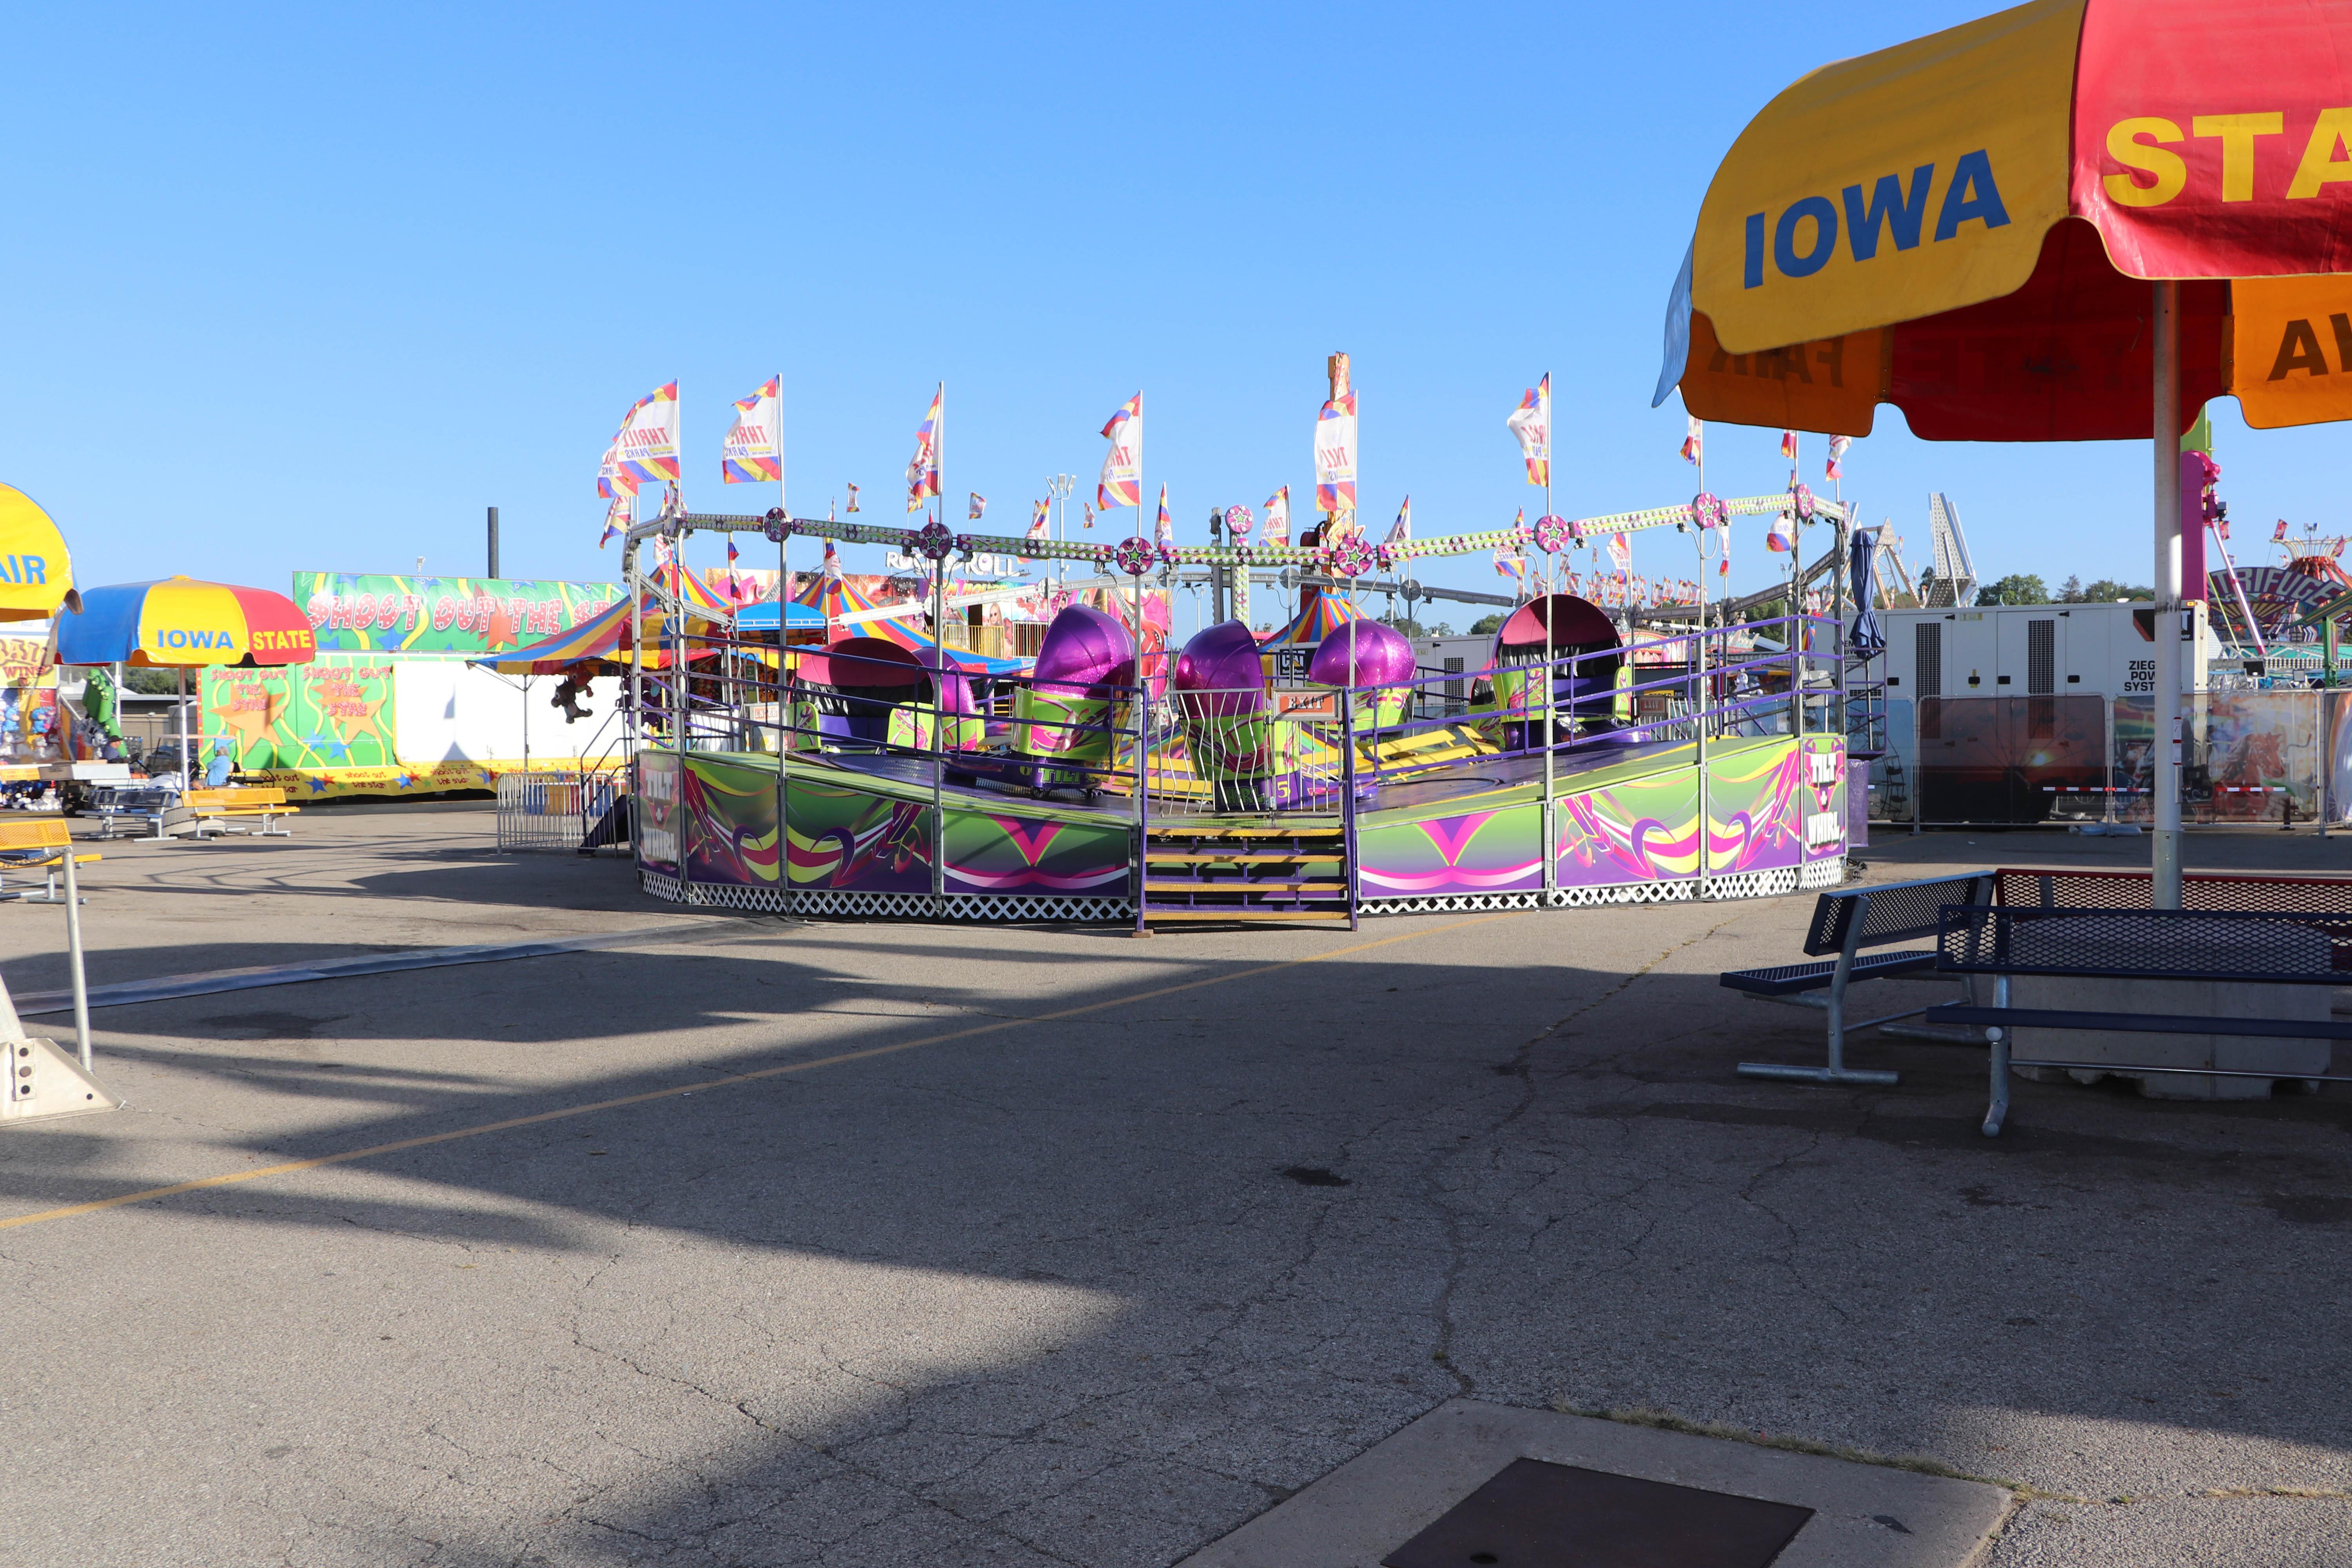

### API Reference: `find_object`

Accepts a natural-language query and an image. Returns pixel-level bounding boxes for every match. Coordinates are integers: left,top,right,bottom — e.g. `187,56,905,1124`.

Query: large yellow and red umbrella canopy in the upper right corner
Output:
1653,0,2352,439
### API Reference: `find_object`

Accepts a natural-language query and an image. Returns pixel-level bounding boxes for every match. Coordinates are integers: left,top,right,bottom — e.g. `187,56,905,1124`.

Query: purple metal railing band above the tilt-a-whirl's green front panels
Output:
642,616,1842,820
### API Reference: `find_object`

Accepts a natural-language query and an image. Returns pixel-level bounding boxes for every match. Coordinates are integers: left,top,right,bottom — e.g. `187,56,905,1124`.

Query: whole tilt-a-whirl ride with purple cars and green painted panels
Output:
560,486,1846,931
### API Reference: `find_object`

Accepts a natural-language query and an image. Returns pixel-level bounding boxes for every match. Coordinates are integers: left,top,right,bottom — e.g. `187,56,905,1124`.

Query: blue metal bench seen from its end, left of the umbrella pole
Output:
1717,872,1992,1084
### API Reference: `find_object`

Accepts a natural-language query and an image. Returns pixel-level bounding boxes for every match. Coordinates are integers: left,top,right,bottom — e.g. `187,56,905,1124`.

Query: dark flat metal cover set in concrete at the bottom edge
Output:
1381,1460,1813,1568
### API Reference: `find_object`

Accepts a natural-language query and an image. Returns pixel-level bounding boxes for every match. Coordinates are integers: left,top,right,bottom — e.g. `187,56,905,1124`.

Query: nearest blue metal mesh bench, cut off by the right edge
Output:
1926,905,2352,1138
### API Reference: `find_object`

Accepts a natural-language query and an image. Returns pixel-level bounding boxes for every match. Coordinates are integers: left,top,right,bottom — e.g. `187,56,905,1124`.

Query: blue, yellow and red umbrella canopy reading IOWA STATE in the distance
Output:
56,576,318,670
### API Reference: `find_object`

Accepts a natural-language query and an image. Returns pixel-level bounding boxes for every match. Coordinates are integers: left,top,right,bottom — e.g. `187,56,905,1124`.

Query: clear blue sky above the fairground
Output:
0,2,2345,623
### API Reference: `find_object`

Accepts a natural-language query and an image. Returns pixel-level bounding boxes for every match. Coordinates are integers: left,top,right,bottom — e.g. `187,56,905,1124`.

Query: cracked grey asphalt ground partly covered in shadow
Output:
0,809,2352,1568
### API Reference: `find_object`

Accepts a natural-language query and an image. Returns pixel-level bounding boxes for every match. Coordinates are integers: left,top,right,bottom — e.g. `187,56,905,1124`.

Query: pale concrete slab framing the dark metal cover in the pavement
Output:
1181,1399,2016,1568
